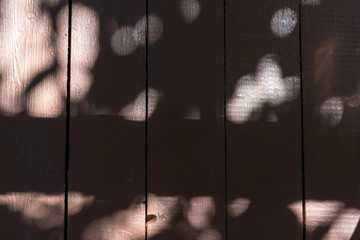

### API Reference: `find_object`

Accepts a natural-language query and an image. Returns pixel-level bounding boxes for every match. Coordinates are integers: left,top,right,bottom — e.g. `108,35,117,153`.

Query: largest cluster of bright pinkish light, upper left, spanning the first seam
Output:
0,0,99,118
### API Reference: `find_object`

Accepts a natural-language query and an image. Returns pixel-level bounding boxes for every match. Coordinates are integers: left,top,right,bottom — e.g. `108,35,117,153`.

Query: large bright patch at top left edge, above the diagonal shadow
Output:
0,0,55,116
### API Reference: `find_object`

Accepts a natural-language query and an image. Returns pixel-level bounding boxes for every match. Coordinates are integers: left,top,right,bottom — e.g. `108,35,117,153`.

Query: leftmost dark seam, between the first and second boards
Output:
64,0,72,240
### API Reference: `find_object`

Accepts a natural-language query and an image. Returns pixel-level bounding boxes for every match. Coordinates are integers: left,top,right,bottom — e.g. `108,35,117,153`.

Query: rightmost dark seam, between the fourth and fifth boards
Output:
298,0,306,240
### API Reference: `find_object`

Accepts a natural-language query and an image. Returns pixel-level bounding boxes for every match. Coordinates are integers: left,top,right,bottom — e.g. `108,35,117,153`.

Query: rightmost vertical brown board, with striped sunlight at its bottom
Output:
302,0,360,239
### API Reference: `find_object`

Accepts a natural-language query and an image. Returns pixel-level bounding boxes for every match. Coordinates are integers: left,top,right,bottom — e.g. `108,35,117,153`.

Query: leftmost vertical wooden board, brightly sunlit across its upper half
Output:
0,0,67,240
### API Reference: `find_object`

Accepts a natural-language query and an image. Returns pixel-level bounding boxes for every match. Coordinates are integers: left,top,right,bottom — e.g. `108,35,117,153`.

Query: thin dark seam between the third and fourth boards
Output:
223,0,228,240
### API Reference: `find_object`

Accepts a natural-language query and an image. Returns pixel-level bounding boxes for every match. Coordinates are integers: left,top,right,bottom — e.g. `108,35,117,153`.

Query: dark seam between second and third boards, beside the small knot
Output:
144,0,149,240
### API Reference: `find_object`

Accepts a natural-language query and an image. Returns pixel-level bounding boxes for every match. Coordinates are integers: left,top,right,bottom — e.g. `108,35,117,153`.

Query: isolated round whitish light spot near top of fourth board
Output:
271,8,297,38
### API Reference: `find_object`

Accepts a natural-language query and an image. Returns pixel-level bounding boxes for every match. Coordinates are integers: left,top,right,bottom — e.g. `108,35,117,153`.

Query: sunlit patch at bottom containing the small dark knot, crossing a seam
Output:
82,194,183,240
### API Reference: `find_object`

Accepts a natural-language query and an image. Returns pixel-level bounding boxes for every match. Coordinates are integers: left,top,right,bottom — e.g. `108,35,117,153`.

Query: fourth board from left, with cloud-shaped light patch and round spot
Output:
226,0,302,240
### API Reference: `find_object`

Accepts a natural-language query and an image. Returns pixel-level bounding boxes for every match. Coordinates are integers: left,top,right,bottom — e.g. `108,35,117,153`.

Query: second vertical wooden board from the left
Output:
68,0,146,240
